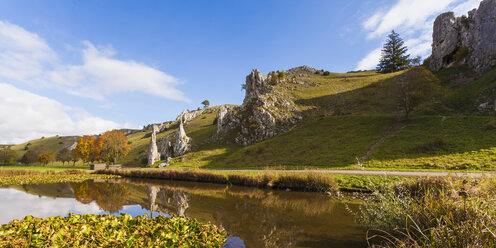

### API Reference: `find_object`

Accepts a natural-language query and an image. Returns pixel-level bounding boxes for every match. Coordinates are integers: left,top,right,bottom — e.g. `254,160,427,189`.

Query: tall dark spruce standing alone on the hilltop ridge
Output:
377,30,410,73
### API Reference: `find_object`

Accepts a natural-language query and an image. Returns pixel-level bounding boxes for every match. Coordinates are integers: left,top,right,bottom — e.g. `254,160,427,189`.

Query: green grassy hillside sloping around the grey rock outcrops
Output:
10,67,496,169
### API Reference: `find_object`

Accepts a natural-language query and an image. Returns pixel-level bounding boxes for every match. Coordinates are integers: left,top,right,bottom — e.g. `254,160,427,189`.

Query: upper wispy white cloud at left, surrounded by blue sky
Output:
0,21,189,101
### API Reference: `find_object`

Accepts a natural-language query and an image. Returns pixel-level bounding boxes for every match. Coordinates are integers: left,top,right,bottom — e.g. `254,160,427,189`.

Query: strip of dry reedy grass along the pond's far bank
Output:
94,169,411,195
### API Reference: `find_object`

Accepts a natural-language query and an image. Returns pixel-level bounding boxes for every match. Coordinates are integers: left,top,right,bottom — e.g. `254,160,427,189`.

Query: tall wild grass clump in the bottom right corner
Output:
359,178,496,247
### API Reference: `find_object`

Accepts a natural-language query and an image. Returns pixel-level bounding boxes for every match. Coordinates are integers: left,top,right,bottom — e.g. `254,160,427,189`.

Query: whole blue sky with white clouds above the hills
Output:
0,0,480,143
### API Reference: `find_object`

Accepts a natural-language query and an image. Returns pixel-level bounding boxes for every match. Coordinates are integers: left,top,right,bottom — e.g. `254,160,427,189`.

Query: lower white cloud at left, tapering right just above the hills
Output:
0,83,130,144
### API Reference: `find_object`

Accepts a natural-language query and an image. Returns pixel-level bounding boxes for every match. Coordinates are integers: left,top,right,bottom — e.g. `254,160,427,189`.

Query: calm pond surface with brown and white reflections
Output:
0,179,366,248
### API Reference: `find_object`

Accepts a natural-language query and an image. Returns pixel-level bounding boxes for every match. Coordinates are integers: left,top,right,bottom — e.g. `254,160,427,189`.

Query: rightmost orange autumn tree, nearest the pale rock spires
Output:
99,130,131,164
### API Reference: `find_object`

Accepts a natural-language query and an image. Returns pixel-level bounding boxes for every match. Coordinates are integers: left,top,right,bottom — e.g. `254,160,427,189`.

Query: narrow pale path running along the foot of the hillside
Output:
216,170,496,178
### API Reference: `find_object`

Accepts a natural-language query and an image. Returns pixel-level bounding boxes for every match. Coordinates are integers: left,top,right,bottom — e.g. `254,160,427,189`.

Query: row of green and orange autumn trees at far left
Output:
0,130,131,166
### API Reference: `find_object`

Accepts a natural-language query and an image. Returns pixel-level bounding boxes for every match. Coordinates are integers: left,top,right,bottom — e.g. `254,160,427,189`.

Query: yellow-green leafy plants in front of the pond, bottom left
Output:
0,214,226,247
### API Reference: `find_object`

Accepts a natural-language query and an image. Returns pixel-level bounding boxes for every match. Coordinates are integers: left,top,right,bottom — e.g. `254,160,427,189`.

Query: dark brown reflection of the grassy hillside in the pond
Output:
117,180,366,247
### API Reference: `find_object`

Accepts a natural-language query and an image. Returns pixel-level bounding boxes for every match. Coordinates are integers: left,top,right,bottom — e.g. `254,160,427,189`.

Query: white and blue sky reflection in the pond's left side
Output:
0,188,245,248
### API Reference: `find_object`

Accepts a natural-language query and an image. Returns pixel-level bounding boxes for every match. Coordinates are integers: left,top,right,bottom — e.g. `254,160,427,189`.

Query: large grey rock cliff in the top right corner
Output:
429,0,496,73
